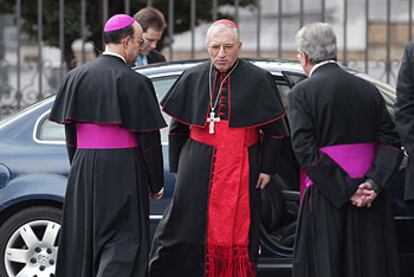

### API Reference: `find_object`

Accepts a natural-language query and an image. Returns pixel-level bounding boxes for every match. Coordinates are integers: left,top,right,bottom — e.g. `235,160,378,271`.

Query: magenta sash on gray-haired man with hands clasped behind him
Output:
300,143,376,195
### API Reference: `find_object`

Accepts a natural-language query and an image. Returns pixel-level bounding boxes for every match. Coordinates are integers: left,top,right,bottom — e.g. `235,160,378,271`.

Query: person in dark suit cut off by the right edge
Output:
395,42,414,202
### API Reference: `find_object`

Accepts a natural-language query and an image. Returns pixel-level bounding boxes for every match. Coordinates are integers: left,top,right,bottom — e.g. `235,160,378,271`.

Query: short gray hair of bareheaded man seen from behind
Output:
296,22,337,64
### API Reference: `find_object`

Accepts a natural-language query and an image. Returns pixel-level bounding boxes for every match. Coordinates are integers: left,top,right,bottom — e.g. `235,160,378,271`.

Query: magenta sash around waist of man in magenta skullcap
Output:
76,123,138,149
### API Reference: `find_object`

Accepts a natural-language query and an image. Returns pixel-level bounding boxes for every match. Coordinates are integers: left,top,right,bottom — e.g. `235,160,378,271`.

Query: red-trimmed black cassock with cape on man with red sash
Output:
149,60,288,277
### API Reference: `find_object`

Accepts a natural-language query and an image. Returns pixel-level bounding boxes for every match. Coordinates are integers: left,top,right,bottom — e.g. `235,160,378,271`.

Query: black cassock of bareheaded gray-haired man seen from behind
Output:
289,63,402,277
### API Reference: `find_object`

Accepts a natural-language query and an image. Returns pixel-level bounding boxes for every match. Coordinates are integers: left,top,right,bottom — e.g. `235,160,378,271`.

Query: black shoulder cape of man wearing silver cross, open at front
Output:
161,60,285,128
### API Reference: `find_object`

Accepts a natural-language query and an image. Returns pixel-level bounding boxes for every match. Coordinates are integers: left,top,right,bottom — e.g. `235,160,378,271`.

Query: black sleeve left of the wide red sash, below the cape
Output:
168,119,190,173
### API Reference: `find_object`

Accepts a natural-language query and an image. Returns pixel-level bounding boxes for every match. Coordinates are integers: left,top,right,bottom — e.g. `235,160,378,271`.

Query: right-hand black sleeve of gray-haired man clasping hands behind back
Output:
366,93,403,192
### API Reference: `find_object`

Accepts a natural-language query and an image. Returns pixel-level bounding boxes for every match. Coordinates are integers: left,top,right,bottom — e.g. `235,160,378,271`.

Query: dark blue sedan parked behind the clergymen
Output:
0,59,414,277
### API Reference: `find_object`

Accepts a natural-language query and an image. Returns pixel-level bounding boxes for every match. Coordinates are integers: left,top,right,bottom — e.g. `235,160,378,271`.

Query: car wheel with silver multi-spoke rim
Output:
0,206,61,277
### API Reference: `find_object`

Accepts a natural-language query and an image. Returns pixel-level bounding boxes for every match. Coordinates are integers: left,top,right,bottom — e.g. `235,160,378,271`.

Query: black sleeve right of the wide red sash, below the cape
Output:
260,115,289,175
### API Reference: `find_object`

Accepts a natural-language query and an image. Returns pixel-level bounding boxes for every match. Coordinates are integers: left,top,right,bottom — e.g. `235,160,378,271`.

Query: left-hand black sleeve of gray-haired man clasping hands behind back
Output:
289,87,358,207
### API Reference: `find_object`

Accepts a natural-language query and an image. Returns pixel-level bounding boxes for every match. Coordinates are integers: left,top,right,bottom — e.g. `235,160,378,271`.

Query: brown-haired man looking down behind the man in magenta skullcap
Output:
134,7,166,66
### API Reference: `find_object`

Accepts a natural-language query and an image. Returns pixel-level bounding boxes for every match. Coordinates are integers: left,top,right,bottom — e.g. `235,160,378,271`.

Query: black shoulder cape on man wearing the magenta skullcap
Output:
50,55,166,132
